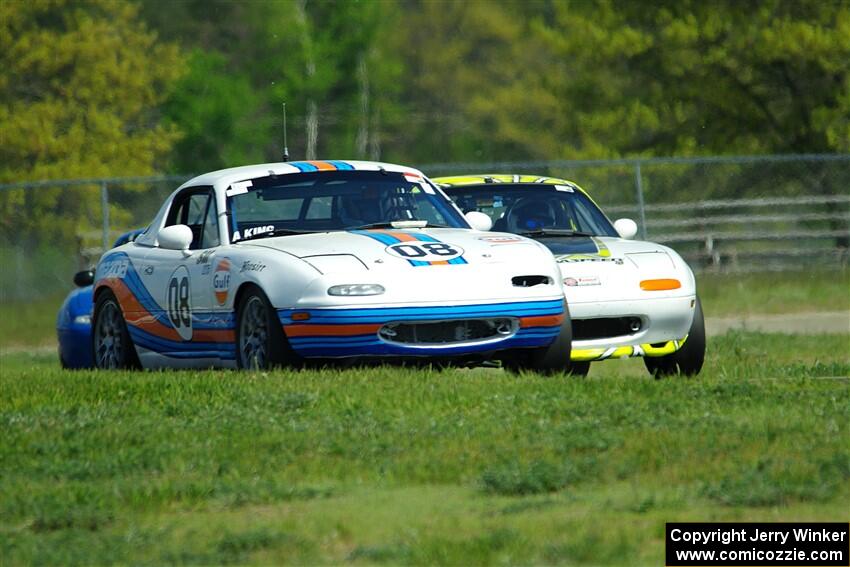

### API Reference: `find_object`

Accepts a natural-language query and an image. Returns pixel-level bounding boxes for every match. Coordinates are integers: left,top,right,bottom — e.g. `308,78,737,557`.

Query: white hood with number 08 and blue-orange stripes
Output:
239,228,552,274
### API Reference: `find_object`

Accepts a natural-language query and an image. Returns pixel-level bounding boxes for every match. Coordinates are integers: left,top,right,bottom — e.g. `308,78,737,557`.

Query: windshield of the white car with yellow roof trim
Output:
444,183,617,236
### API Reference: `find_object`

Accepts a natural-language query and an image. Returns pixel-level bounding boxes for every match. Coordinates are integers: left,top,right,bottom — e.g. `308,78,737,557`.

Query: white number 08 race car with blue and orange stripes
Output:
92,161,571,371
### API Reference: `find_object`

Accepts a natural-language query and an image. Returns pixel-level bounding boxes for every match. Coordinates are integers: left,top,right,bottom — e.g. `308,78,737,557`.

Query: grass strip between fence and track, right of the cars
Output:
697,268,850,317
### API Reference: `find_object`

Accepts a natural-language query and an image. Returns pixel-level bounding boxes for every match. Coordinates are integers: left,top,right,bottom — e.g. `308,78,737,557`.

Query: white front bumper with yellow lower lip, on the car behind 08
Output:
570,295,696,361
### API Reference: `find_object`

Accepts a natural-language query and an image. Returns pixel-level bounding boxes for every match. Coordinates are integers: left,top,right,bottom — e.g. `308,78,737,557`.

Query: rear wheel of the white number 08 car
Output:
92,289,142,370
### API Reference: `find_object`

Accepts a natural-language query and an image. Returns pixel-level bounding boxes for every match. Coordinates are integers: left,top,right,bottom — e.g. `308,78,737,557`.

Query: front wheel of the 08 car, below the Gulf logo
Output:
236,286,300,370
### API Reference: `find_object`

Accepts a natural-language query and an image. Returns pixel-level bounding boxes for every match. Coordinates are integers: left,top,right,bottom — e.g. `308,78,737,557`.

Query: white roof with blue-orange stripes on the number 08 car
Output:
180,160,424,193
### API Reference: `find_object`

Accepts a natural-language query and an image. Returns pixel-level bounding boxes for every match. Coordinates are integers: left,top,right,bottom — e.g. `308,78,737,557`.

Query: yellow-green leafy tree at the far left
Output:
0,0,182,241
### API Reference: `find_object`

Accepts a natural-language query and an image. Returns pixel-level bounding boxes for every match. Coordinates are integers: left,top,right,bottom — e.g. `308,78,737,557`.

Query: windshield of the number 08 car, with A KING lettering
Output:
227,171,469,242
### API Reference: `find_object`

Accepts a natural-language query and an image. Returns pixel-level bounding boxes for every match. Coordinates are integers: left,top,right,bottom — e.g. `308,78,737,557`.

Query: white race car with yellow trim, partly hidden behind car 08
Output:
434,175,705,376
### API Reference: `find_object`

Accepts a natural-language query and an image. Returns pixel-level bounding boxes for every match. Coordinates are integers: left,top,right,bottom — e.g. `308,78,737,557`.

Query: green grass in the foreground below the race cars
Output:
0,333,850,565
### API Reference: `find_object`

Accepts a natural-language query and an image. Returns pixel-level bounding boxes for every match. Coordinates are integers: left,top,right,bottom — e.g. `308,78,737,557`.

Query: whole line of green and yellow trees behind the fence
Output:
0,0,850,241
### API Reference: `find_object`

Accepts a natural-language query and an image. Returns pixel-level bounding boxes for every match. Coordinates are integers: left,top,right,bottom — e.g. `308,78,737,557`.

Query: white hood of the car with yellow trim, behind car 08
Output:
540,236,694,303
